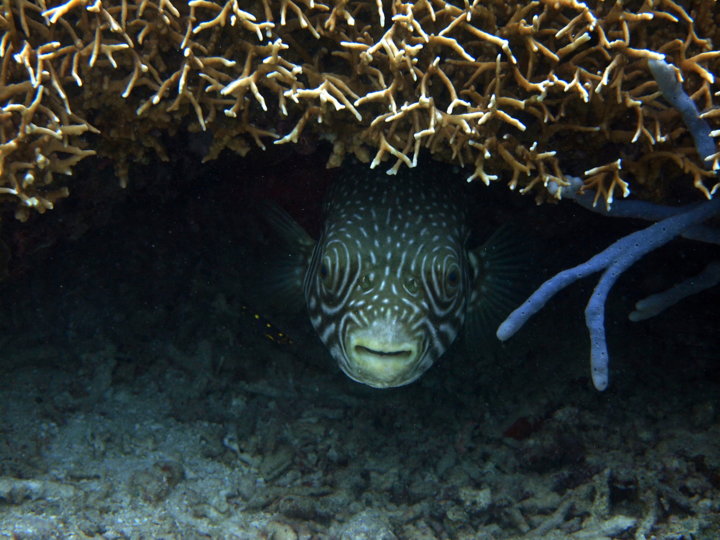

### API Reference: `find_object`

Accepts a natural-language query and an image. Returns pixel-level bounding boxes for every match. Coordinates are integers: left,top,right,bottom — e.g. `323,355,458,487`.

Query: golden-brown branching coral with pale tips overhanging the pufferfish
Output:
0,0,720,218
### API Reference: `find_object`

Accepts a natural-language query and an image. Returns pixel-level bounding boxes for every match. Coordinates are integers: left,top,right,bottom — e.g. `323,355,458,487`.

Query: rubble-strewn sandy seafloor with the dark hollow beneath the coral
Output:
0,153,720,539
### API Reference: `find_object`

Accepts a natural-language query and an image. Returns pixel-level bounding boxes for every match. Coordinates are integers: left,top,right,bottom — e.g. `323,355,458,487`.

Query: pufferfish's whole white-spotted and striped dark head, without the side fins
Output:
304,173,470,388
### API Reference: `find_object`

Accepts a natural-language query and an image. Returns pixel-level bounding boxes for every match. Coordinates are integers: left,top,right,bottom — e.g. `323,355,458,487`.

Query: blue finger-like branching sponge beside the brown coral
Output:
497,58,720,390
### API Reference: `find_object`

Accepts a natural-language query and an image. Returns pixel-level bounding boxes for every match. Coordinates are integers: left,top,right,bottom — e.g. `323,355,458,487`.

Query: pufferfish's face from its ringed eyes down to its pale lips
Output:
305,235,468,388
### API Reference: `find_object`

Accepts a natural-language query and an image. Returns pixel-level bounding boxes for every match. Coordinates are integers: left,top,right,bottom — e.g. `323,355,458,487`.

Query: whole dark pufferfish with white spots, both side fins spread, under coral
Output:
265,165,520,388
